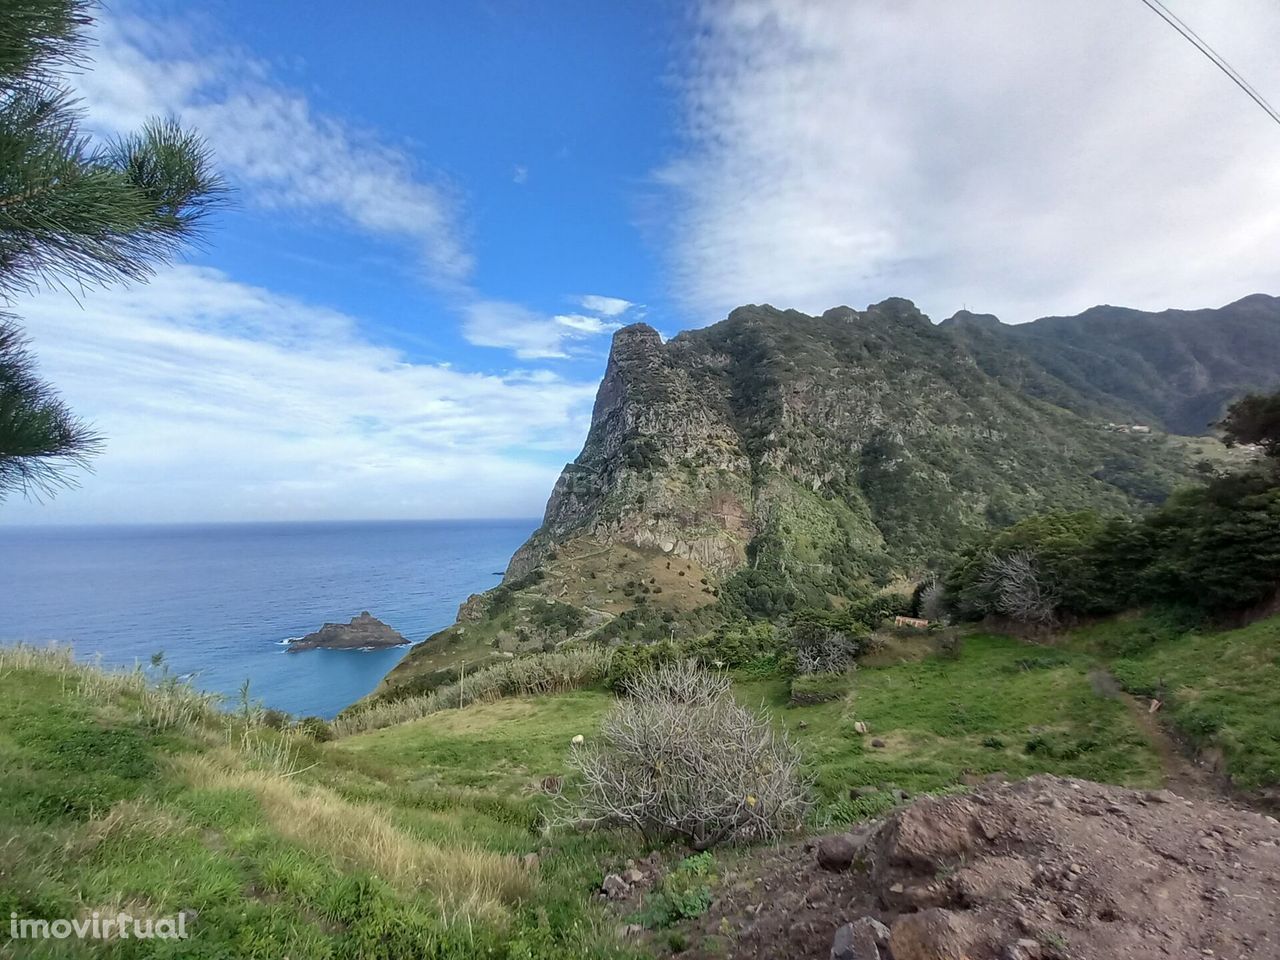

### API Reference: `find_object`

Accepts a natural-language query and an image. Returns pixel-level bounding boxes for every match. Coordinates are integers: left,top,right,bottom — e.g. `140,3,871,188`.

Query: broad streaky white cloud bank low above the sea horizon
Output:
5,266,595,522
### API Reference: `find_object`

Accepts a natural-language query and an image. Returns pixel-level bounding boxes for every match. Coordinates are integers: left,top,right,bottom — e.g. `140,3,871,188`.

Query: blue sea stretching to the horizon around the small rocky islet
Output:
0,520,538,717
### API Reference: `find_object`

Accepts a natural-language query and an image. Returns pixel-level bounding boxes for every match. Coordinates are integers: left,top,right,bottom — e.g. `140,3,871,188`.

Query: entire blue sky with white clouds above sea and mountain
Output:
3,0,1280,524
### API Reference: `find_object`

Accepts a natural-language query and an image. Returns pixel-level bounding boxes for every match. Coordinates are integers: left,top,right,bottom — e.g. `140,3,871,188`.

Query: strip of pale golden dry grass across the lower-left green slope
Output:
179,753,532,920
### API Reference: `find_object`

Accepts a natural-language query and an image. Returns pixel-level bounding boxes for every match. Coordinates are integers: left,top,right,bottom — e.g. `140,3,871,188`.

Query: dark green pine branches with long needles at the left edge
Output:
0,0,225,499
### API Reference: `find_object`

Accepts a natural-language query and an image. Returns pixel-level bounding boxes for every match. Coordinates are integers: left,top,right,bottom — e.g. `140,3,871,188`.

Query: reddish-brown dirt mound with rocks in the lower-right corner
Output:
690,777,1280,960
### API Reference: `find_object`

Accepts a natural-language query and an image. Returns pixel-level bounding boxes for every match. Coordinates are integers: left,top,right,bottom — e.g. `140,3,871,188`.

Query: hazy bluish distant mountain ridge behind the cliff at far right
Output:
942,293,1280,435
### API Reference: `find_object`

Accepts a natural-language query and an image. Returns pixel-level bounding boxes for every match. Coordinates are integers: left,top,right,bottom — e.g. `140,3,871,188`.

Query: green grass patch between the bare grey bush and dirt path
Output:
740,635,1160,826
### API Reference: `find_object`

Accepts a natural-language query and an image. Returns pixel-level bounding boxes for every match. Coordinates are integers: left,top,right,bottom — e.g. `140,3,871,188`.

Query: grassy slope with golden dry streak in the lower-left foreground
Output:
0,654,645,960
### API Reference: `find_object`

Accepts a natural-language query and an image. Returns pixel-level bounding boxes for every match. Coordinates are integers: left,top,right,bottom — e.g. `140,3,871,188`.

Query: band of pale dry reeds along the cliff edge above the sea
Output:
333,646,612,737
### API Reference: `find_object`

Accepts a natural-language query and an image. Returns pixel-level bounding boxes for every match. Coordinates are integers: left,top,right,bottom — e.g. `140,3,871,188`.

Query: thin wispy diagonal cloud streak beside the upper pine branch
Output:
76,14,472,285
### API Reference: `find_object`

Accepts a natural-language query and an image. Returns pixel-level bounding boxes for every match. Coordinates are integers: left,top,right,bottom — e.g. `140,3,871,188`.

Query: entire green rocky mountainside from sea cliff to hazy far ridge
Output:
381,297,1280,695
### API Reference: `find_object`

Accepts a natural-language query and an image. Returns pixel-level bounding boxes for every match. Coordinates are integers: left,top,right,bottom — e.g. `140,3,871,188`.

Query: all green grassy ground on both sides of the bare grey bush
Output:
0,620,1280,960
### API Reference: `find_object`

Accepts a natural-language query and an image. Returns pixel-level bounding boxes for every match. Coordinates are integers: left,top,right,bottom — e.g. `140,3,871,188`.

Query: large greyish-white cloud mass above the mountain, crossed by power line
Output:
659,0,1280,320
